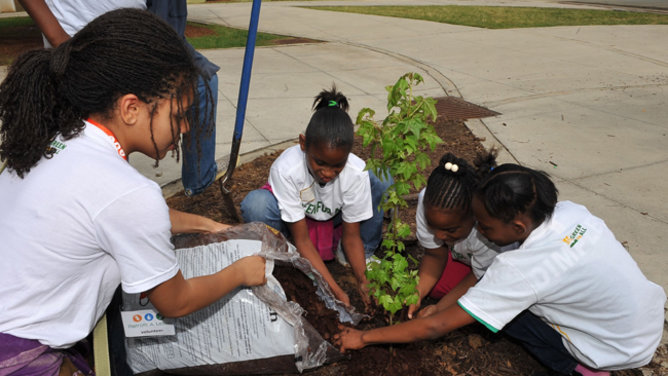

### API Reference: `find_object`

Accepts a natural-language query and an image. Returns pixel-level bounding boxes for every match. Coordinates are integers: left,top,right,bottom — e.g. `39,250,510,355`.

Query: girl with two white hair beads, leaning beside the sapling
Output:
408,150,508,318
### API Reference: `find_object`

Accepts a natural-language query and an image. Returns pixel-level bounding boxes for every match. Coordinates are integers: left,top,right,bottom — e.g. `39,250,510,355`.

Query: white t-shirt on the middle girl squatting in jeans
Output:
269,145,373,223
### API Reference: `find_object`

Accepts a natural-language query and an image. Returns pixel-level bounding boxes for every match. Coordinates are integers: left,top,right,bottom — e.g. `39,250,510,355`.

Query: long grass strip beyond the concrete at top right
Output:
308,5,668,29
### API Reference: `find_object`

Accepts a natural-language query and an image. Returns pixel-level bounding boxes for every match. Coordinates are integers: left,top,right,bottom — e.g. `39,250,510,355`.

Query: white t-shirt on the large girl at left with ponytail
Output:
0,123,178,347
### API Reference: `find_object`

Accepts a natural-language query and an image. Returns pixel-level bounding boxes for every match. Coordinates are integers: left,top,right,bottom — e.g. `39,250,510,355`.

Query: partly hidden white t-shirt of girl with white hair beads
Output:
415,188,508,279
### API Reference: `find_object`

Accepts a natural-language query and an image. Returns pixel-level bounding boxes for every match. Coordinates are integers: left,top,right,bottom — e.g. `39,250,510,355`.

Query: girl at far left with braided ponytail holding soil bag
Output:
0,10,265,375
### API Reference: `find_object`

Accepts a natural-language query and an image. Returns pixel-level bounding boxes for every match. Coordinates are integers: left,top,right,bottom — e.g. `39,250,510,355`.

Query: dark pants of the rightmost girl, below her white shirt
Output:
503,311,578,375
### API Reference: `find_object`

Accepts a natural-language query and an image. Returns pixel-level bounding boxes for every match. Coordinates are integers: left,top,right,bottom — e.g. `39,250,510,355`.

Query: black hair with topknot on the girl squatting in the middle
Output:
304,85,354,151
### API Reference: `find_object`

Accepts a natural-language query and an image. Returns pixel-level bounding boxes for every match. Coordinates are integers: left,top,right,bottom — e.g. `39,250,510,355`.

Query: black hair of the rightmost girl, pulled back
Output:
476,163,558,224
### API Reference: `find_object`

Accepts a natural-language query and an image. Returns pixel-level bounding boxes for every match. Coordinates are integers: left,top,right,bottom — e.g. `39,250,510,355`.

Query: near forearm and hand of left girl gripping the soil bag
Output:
148,256,267,317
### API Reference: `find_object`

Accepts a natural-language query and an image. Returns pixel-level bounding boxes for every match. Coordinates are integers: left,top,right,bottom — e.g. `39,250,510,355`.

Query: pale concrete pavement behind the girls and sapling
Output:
174,1,668,312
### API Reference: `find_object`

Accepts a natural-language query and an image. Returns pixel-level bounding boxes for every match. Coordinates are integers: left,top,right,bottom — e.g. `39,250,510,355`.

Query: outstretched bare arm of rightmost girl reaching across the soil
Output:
334,305,475,352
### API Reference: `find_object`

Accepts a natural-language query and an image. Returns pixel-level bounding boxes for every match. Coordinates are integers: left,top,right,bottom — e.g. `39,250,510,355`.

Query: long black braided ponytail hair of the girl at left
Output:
0,9,211,177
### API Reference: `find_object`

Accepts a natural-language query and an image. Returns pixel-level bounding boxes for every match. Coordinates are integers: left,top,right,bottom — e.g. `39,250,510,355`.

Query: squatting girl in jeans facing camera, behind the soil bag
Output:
241,87,392,305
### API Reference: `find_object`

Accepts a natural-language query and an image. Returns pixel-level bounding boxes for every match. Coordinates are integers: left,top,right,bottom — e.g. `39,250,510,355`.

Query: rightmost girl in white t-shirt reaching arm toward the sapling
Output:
337,164,666,375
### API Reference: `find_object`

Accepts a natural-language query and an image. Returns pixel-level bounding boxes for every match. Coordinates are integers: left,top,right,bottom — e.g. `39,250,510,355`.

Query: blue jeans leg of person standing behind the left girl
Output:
181,73,218,196
